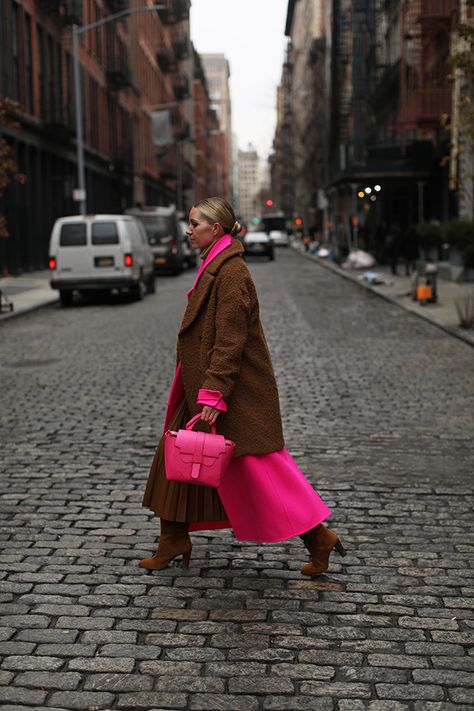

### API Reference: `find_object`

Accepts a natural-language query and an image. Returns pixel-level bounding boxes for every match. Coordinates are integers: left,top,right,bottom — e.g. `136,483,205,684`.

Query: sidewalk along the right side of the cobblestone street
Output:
296,250,474,346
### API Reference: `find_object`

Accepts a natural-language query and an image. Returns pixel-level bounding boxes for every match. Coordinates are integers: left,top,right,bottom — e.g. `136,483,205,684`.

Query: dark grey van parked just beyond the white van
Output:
125,205,186,274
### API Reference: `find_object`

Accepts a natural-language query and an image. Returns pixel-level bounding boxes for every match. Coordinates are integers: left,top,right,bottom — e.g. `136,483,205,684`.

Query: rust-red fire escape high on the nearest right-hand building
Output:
400,0,458,138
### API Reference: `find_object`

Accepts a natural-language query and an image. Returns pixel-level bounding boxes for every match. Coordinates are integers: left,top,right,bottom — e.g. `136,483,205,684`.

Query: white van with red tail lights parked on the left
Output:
49,215,155,306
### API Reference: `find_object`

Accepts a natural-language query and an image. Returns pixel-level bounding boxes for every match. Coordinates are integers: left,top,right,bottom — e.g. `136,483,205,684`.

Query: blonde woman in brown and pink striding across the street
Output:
139,197,345,575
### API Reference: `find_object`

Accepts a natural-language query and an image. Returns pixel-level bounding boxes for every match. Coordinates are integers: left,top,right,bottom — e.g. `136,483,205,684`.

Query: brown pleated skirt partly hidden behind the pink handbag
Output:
142,399,227,523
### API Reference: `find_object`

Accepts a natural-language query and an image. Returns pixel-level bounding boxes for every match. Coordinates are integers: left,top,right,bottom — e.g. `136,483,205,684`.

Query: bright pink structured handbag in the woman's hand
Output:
164,414,235,487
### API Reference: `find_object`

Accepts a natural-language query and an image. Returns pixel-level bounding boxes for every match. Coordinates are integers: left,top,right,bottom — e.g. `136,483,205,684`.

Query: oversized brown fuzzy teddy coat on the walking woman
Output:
178,240,284,456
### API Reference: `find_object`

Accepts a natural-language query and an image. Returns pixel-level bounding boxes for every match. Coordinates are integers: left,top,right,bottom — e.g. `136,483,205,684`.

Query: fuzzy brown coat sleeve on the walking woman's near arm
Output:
201,268,251,402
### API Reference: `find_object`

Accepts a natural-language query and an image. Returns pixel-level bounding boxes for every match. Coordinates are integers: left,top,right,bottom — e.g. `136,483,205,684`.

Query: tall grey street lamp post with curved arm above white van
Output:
72,5,166,215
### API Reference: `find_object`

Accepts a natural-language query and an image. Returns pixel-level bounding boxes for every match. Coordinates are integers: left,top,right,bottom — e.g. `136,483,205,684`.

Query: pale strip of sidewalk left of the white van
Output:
0,270,59,322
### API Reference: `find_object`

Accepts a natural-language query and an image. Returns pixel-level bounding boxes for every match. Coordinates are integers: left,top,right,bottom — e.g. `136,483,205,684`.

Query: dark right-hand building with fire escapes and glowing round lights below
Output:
327,0,459,257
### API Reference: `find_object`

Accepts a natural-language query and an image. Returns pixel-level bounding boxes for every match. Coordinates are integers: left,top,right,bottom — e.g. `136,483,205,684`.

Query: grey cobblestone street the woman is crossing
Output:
0,250,474,711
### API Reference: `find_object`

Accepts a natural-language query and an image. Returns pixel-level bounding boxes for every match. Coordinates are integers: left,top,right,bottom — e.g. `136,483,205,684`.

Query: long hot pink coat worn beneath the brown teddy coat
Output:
165,235,331,542
